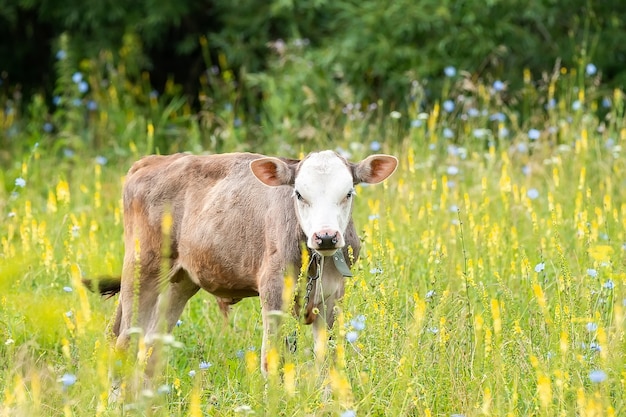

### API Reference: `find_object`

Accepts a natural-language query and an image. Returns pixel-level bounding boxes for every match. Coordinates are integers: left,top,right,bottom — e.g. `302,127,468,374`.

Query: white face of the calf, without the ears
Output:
294,151,354,255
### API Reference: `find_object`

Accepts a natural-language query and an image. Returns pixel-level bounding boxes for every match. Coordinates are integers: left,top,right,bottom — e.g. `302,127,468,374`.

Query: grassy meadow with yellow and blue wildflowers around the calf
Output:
0,58,626,417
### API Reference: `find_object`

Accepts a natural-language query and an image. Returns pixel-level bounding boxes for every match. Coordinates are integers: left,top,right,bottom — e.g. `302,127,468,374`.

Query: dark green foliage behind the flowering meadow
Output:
0,0,626,111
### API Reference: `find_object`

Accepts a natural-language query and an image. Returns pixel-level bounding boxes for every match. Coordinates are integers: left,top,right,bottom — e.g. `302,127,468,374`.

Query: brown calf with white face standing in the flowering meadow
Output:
89,151,397,373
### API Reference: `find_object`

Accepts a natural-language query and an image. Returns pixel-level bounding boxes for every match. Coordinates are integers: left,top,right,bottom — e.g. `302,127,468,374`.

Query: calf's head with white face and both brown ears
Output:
250,151,398,256
